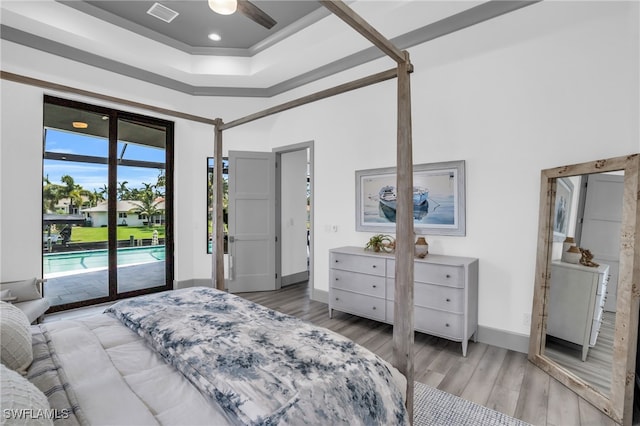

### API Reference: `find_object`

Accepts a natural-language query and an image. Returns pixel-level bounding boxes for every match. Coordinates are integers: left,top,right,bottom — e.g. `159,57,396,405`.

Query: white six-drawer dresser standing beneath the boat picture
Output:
329,247,478,356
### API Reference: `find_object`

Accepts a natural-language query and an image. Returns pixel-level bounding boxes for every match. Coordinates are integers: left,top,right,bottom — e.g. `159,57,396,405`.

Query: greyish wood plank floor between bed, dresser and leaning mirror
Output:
240,283,615,426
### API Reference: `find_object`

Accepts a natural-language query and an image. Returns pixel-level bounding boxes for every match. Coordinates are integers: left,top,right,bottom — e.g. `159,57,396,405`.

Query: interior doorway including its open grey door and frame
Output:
225,142,314,293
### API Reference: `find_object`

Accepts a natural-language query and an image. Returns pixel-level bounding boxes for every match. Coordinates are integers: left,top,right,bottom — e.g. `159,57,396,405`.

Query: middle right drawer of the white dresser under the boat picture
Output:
387,278,464,314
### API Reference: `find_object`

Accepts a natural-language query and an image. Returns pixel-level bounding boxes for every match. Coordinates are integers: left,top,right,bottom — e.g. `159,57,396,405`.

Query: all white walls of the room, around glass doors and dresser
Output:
0,1,640,340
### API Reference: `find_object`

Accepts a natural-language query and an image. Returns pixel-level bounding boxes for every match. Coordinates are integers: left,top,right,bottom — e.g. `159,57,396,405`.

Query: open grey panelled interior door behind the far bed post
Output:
228,151,276,293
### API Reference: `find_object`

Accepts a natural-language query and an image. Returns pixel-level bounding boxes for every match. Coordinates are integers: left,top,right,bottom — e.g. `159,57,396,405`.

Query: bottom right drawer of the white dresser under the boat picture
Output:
387,301,464,341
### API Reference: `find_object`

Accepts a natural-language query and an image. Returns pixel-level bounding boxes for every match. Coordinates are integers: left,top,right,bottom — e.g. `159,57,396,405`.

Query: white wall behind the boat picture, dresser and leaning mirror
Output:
252,2,640,334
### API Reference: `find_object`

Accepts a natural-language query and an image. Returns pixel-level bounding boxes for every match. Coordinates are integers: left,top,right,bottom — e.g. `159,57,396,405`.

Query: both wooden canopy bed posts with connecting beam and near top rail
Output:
213,0,414,416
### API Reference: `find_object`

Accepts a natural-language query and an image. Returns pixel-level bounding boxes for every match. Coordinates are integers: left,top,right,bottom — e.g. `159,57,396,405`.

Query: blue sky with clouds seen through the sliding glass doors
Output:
43,129,165,191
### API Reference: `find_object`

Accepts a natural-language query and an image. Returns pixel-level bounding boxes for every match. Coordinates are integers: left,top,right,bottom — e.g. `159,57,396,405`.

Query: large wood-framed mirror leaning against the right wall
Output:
529,154,640,425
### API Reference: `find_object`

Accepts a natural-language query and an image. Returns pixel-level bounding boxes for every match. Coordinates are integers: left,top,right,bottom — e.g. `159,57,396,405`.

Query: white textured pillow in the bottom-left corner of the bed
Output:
0,365,53,425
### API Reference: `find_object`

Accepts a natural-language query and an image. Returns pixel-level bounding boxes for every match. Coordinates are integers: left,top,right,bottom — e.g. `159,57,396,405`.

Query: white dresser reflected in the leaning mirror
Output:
547,260,609,361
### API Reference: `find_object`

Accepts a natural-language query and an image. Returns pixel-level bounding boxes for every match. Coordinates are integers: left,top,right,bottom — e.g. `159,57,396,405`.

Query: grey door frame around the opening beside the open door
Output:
272,140,315,298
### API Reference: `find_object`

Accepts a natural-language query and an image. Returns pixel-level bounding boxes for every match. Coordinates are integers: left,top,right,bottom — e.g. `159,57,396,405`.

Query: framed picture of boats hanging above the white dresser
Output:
356,160,466,236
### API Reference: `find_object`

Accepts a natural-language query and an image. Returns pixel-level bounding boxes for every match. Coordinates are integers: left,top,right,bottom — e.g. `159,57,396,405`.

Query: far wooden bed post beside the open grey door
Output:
211,118,225,290
